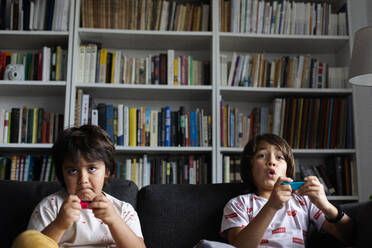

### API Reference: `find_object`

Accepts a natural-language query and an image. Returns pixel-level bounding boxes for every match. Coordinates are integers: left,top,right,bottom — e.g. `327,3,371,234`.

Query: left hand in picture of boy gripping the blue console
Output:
268,177,293,210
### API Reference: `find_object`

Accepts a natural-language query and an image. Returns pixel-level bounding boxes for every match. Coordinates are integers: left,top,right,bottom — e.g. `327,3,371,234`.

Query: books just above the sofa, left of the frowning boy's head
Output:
0,155,56,182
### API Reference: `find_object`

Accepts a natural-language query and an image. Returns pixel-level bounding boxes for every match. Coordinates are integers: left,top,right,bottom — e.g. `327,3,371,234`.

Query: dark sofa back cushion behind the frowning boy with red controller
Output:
0,180,138,247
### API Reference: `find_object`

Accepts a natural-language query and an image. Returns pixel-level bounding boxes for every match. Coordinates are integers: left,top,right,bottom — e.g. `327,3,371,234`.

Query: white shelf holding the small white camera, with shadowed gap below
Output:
0,80,66,96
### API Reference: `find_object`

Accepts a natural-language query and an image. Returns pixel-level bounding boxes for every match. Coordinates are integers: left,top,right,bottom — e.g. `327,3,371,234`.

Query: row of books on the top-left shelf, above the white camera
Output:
0,0,70,31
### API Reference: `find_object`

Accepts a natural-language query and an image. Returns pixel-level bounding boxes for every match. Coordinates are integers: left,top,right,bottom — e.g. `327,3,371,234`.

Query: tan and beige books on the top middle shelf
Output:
81,0,210,31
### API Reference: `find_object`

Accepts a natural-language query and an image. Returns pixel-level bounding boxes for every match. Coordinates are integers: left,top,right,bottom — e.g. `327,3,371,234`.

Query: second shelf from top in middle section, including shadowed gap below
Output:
76,83,212,101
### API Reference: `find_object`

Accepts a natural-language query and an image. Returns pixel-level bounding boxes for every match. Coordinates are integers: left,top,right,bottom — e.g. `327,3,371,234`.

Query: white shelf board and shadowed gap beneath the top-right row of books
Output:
219,32,349,54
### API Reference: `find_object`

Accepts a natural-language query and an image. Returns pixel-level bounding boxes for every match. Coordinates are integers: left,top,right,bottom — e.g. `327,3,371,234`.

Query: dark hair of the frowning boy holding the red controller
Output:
52,125,115,187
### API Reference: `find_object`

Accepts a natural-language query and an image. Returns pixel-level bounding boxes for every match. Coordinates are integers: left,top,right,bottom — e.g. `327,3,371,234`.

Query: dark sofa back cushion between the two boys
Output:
138,184,250,248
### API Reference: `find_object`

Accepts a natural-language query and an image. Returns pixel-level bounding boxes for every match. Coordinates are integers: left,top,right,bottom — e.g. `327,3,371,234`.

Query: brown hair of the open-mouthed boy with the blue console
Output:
240,133,295,191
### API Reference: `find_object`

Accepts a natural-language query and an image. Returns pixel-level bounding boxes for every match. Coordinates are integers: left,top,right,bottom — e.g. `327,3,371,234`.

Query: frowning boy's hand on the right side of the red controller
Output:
88,195,119,225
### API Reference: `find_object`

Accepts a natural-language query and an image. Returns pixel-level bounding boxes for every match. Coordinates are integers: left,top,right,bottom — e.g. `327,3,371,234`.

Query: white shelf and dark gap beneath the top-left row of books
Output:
0,30,69,50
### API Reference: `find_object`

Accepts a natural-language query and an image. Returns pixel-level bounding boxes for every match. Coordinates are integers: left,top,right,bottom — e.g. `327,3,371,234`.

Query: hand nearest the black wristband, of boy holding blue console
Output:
298,176,329,209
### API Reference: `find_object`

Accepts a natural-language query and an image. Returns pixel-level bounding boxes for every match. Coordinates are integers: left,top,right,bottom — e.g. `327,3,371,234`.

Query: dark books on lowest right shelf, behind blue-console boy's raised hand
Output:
296,157,358,195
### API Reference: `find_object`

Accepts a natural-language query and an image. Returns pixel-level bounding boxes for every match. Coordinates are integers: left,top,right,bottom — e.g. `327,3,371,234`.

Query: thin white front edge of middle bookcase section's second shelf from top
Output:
75,83,212,90
